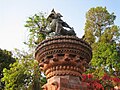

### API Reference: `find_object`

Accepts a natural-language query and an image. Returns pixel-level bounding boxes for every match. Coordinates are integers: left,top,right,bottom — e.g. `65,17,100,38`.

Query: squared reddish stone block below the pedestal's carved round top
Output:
43,76,87,90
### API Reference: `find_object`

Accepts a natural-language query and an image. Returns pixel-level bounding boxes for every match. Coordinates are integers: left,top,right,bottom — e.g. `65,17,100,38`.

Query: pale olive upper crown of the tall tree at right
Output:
84,7,120,44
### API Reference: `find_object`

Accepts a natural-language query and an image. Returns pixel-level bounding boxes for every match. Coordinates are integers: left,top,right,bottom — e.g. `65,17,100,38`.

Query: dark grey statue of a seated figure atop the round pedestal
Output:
41,9,76,36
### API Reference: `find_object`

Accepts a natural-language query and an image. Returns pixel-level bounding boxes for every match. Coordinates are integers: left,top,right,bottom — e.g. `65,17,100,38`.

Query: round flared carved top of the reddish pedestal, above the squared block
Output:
35,36,92,79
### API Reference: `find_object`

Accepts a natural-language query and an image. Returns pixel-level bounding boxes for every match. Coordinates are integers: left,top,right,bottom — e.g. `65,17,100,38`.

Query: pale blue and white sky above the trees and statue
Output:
0,0,120,51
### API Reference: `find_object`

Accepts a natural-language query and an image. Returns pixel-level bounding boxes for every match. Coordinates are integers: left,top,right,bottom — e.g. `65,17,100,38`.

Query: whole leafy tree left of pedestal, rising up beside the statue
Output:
2,13,46,90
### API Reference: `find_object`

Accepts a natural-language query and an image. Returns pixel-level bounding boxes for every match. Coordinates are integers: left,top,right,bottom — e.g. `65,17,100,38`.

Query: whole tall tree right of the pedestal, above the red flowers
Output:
83,7,120,76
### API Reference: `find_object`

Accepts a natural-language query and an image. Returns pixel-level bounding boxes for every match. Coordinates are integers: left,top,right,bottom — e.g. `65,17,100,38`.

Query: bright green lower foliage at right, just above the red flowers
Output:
91,42,120,76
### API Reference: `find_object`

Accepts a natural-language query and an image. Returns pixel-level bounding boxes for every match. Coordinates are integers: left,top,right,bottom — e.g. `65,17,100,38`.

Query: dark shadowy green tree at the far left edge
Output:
0,49,15,89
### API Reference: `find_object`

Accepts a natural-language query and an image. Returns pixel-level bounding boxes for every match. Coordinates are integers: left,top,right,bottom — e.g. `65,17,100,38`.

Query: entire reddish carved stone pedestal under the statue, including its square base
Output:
35,36,92,90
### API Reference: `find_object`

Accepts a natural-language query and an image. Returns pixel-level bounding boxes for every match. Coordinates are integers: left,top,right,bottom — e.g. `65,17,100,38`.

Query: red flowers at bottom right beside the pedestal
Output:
82,74,117,90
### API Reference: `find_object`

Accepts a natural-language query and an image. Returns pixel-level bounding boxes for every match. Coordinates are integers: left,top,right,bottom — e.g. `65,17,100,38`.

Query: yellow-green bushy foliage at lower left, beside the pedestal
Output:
2,50,46,90
